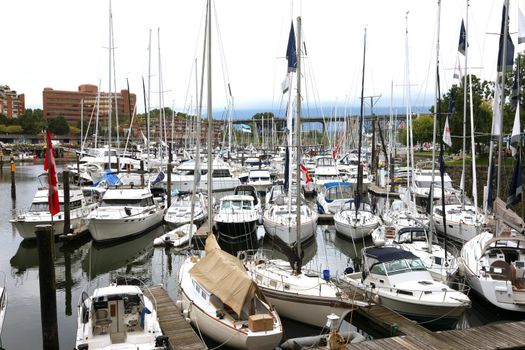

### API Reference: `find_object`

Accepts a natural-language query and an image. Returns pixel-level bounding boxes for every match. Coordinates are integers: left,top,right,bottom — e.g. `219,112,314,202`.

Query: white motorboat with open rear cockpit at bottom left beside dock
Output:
75,284,169,350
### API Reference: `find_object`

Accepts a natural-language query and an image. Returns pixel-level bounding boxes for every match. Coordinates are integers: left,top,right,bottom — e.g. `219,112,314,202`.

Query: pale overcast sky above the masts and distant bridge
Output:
0,0,523,115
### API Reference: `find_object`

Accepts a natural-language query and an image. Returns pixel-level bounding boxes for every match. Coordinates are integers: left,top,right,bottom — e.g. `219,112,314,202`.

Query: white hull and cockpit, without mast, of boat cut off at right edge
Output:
461,230,525,312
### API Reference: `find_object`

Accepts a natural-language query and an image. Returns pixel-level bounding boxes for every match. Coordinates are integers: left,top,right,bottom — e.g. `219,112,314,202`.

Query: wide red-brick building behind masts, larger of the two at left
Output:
42,84,137,126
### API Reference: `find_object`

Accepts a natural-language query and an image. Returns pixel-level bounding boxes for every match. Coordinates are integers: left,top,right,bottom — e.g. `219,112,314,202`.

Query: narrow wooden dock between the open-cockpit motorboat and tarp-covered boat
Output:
144,286,207,350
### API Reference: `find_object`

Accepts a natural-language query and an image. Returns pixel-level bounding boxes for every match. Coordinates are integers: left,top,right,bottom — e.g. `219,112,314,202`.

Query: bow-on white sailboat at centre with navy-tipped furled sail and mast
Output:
263,18,318,249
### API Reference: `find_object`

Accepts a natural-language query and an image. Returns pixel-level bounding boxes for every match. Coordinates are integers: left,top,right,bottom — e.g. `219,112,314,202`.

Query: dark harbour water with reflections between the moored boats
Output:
0,163,523,349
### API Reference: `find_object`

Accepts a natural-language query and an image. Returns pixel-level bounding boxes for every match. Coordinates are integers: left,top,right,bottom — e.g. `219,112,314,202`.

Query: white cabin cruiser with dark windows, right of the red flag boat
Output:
88,184,164,243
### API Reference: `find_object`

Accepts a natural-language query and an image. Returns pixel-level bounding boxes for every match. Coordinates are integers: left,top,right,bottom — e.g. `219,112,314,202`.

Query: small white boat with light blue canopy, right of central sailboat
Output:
316,182,354,215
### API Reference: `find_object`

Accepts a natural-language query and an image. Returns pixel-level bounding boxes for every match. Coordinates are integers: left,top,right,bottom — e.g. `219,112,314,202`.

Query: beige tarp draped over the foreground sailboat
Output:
189,234,257,315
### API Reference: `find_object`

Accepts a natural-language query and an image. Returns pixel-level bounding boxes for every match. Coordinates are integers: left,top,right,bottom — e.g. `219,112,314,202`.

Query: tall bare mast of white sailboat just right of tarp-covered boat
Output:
290,17,301,273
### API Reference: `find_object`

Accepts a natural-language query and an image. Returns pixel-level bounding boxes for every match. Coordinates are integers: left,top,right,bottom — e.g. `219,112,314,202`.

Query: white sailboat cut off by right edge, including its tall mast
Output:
461,0,525,312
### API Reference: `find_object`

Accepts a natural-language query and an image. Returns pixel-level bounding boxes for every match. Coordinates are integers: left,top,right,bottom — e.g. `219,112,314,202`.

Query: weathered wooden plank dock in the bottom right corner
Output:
347,321,525,350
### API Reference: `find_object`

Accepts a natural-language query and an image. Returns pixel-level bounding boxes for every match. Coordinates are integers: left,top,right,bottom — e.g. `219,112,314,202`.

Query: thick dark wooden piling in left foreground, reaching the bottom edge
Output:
35,225,59,350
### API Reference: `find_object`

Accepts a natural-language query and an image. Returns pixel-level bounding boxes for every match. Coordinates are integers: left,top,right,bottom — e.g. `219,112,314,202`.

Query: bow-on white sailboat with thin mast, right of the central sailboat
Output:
334,29,379,239
